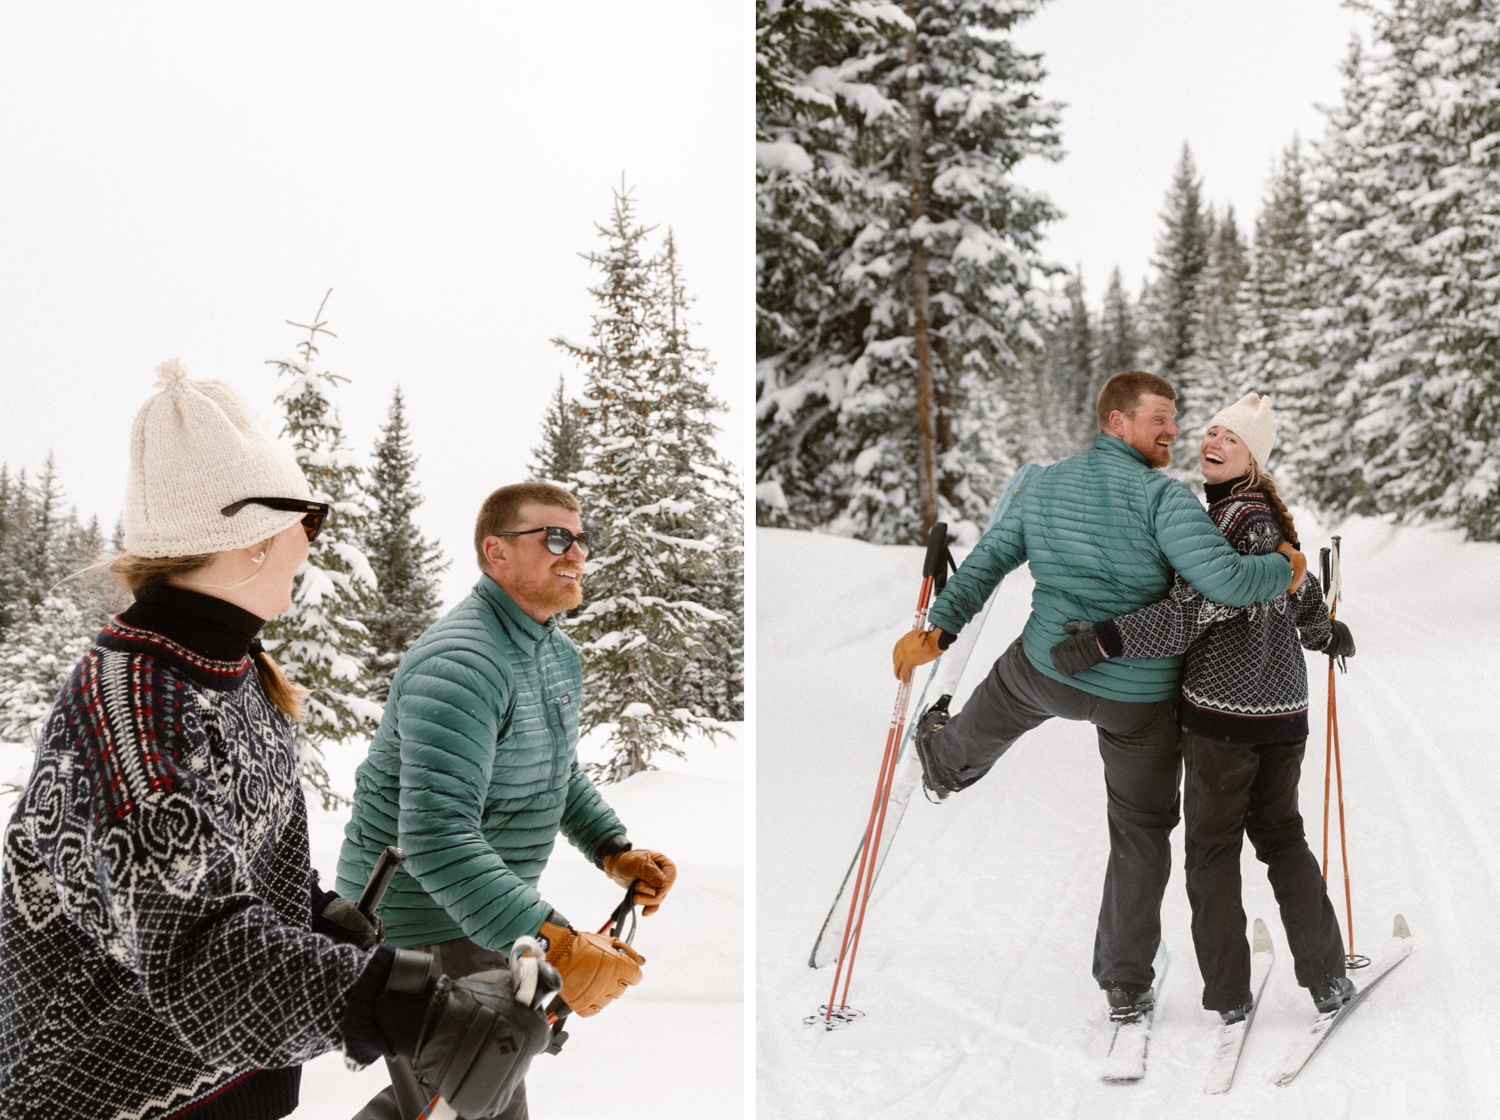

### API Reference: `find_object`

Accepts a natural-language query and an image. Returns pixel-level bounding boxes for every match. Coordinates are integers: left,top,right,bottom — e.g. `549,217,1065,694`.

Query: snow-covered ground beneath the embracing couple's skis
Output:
756,514,1500,1120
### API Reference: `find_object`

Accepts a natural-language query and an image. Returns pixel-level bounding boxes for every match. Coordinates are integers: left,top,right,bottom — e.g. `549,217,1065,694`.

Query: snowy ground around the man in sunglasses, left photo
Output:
0,726,746,1120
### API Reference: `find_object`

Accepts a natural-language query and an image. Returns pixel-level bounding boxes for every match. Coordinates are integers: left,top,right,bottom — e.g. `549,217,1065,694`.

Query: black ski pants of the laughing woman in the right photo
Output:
1182,729,1344,1011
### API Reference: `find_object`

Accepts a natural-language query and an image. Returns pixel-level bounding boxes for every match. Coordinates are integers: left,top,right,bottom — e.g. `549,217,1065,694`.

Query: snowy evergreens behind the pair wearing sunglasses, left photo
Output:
0,189,744,810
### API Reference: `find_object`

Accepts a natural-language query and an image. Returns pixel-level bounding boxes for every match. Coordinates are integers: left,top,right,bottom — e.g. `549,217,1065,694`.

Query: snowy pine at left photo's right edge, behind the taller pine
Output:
656,228,744,721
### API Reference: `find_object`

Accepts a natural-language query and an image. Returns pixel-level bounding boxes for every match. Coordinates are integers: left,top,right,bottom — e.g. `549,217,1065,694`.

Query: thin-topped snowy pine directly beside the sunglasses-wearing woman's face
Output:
264,289,381,808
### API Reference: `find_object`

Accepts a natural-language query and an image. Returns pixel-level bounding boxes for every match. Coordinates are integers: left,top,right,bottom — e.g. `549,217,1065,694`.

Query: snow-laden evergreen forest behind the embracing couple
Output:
756,0,1500,543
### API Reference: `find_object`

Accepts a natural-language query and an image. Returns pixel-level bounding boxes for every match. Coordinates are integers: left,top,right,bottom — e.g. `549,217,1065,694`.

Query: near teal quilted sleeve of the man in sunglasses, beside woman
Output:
396,648,552,946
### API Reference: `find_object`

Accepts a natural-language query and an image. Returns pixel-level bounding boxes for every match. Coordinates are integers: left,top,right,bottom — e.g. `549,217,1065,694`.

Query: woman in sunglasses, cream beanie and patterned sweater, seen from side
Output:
0,361,548,1120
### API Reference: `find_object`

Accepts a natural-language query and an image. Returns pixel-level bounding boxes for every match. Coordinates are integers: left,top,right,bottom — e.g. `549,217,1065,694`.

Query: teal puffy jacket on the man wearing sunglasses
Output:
338,576,626,952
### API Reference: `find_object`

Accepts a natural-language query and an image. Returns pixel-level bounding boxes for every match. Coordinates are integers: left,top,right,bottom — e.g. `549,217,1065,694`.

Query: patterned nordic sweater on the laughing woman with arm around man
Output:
1094,487,1332,744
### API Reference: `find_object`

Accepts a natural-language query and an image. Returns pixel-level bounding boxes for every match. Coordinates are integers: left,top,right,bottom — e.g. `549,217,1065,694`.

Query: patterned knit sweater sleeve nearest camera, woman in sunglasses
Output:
38,662,366,1068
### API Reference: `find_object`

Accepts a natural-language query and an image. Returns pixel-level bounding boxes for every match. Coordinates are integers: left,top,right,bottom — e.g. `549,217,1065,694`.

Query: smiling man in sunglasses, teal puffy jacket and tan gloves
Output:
338,483,677,1120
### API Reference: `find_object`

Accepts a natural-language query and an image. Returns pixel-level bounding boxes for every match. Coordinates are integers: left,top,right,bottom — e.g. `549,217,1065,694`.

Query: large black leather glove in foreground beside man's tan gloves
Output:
375,949,552,1116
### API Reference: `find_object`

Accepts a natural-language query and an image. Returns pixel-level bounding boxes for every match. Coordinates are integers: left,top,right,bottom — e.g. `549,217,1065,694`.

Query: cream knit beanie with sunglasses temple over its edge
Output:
125,358,312,556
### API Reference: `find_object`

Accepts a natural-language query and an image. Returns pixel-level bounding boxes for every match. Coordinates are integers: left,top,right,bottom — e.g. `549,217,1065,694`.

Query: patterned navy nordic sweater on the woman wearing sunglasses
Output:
0,591,389,1120
